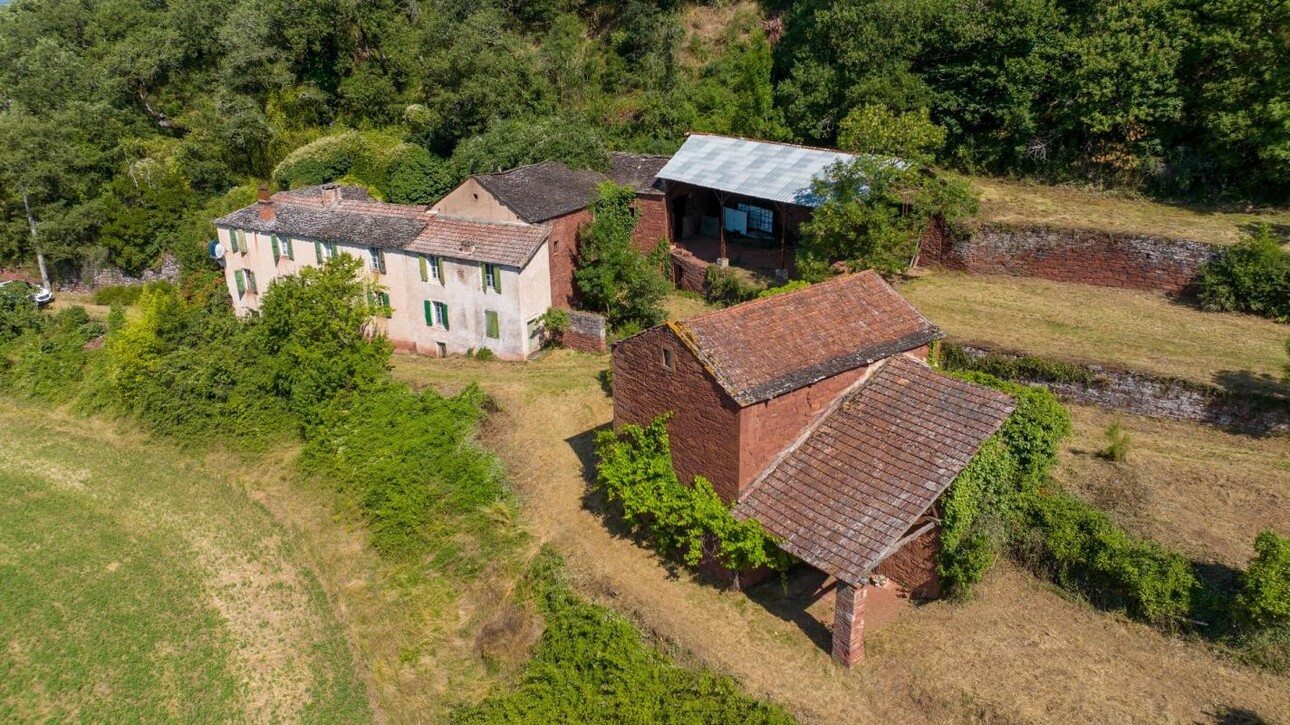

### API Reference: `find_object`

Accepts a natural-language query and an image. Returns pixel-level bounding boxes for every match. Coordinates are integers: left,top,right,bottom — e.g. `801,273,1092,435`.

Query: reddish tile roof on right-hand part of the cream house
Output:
406,214,551,267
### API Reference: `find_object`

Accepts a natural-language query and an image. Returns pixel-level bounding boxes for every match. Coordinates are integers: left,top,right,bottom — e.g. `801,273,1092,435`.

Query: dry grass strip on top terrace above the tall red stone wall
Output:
971,177,1290,244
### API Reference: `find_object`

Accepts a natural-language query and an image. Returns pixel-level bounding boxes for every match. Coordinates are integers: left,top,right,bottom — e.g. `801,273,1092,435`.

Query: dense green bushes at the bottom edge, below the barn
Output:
453,548,793,725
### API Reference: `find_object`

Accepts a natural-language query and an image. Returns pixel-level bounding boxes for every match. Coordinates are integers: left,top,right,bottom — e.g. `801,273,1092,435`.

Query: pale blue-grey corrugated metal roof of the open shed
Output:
658,133,858,206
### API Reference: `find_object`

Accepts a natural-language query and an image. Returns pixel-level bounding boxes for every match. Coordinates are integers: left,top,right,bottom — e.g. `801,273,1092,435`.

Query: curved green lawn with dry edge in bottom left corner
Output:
0,399,370,722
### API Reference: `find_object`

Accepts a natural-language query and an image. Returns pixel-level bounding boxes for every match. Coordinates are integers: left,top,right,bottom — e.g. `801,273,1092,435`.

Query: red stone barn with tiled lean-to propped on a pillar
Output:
613,271,1014,666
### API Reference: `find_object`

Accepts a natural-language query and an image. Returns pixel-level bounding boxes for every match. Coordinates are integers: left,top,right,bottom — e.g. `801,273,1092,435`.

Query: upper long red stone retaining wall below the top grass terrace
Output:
920,224,1222,293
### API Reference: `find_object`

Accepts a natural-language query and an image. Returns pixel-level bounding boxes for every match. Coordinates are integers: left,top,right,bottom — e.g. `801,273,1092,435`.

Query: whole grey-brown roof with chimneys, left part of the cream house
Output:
214,186,430,249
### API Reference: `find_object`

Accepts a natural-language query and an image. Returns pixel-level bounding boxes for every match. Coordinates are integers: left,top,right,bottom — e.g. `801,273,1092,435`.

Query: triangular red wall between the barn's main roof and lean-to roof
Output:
739,366,868,493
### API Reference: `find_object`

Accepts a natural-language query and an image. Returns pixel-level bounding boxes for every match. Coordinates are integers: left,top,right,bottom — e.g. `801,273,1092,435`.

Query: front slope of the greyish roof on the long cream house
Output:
214,200,428,249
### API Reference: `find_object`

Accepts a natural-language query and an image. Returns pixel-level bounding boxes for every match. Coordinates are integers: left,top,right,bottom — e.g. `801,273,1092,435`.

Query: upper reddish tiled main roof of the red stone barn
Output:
670,270,942,405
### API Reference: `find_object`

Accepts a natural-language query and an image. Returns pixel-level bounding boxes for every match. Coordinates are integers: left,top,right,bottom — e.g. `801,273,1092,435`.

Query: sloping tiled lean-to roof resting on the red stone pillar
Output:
734,355,1015,584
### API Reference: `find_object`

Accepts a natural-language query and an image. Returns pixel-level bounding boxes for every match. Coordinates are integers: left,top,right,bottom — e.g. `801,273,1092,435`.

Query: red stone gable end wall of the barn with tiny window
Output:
613,326,739,501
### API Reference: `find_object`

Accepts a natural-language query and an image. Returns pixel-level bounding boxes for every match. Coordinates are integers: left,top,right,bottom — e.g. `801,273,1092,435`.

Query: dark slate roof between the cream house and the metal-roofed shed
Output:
473,154,667,224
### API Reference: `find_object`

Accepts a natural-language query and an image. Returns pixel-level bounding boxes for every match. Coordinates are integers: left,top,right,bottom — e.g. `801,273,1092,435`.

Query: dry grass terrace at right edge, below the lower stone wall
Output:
1055,406,1290,568
